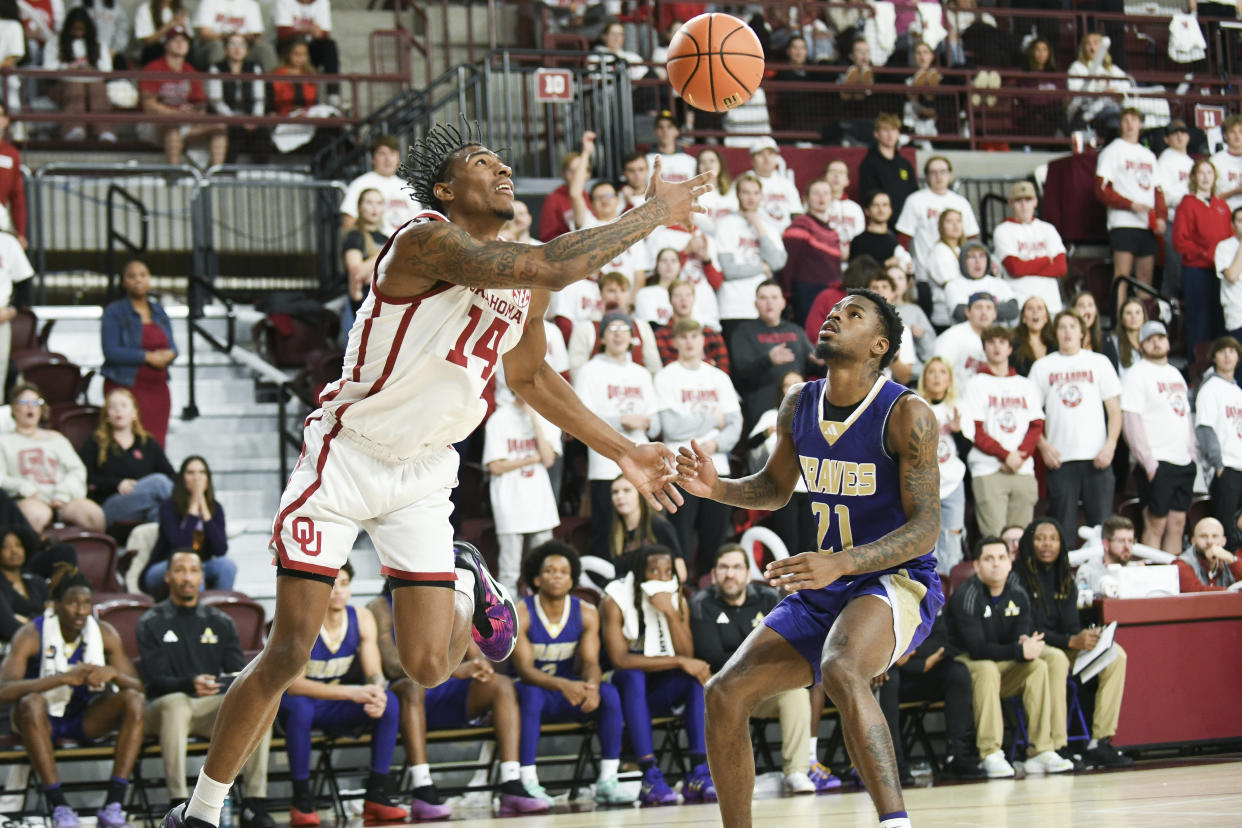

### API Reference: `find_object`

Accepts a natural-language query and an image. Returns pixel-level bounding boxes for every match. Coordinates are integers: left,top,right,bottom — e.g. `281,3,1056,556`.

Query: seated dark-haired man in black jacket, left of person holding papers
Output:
949,536,1073,777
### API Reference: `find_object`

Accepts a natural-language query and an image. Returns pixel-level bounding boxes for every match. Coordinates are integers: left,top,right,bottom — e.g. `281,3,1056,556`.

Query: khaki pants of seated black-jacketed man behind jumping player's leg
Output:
145,693,272,799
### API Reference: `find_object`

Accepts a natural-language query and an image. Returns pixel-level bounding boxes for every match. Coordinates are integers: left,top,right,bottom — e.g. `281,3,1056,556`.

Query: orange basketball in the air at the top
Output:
666,12,764,112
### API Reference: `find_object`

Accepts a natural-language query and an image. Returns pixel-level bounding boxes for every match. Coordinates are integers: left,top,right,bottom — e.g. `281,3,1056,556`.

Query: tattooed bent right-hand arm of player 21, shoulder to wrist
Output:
842,398,940,575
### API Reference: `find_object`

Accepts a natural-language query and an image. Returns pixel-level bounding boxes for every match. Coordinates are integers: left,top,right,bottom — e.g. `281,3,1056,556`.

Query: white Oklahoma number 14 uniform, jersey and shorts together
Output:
272,211,530,582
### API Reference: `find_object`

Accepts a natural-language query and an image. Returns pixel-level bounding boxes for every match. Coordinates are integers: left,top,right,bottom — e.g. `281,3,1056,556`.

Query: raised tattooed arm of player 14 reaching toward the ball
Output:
390,159,712,290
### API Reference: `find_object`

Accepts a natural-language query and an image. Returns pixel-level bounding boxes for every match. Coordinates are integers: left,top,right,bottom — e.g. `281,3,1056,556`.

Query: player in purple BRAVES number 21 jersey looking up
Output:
677,290,944,828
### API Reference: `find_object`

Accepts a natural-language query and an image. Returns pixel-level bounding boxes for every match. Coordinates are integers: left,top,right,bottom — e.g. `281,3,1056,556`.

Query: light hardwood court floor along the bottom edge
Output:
417,758,1242,828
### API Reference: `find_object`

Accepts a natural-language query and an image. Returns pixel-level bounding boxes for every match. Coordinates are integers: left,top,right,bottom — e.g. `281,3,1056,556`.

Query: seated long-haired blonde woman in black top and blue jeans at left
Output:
82,389,176,526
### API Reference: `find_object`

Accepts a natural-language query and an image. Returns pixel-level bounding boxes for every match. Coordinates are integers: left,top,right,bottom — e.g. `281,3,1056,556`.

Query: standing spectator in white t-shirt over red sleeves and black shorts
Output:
1095,107,1169,299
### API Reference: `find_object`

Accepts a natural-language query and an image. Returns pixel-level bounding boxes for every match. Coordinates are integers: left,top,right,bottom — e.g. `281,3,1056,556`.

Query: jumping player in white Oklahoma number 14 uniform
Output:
163,121,710,828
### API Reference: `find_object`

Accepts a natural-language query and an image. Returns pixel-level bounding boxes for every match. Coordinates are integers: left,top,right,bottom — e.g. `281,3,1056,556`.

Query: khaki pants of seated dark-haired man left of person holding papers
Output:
958,655,1048,757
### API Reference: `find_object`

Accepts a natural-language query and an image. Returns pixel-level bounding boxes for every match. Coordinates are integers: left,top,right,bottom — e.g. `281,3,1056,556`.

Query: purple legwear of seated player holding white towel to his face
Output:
609,669,707,758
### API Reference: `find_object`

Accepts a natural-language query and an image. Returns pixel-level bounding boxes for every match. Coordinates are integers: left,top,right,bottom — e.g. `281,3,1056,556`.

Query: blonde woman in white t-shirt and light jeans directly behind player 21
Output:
919,356,966,577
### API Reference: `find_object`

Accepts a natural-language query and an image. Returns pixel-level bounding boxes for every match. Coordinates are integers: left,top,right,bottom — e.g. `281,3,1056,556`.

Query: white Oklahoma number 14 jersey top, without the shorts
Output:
319,210,530,462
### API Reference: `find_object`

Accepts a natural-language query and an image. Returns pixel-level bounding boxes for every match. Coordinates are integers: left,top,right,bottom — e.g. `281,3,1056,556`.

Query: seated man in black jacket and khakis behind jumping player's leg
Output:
137,550,276,828
